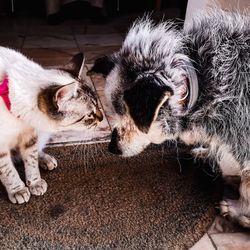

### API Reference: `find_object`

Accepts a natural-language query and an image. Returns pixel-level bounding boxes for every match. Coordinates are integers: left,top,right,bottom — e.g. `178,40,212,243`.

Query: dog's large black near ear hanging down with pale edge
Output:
124,77,173,133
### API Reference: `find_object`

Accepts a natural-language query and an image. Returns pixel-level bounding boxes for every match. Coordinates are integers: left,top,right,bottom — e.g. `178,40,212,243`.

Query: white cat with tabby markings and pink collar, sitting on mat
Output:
0,47,103,204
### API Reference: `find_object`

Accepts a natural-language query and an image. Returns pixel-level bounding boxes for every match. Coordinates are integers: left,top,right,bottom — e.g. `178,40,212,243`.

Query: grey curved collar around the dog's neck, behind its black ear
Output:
171,56,199,112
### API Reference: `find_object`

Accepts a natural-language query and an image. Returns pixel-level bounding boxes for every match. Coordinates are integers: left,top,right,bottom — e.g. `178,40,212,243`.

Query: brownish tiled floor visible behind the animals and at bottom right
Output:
0,14,250,250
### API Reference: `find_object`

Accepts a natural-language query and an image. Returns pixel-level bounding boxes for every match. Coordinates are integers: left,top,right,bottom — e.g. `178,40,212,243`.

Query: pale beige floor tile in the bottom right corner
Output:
210,233,250,250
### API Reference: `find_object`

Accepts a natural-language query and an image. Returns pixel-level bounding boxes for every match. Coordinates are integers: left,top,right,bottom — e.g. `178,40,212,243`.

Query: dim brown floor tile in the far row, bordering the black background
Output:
24,34,77,48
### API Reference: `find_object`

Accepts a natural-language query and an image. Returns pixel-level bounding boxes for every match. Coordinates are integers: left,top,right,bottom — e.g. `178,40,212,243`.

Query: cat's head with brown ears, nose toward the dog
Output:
38,53,103,130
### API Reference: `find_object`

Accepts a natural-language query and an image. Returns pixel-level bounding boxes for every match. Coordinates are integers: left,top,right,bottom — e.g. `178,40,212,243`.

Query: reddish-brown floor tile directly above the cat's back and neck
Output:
22,48,80,66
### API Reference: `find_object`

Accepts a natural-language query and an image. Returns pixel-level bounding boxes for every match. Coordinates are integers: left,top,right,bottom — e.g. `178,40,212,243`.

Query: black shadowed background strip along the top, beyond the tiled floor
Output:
0,0,187,24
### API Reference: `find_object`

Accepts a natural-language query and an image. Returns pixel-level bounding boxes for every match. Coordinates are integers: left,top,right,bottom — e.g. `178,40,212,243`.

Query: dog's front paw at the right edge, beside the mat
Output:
220,199,250,228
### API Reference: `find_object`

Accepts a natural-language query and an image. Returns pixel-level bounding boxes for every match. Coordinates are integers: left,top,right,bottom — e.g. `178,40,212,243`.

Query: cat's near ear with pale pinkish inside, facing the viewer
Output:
54,83,78,109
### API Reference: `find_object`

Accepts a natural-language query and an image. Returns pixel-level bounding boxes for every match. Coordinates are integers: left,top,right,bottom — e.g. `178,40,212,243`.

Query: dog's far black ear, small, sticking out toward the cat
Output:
87,56,115,78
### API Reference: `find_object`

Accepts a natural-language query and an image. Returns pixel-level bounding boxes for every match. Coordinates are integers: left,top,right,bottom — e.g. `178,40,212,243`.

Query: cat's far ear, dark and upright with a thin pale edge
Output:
60,53,85,78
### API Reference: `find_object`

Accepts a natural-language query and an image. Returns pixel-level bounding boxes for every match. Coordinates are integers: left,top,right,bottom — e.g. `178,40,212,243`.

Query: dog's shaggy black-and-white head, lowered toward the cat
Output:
90,19,198,156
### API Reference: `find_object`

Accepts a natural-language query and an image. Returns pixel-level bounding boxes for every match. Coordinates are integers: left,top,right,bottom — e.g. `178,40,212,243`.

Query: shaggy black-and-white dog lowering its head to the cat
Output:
91,11,250,227
